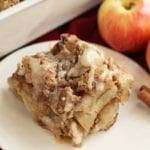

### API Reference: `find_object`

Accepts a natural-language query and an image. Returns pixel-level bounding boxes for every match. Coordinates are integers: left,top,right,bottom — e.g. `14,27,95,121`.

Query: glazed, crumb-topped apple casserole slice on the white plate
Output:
8,34,133,145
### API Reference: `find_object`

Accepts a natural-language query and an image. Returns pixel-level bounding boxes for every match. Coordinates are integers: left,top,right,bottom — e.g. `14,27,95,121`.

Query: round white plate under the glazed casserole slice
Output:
0,42,150,150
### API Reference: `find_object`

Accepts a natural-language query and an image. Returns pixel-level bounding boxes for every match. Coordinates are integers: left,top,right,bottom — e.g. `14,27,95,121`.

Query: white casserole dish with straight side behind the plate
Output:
0,0,101,57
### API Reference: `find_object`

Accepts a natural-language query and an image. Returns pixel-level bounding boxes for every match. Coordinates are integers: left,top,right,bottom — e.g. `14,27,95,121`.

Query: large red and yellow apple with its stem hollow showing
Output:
98,0,150,52
